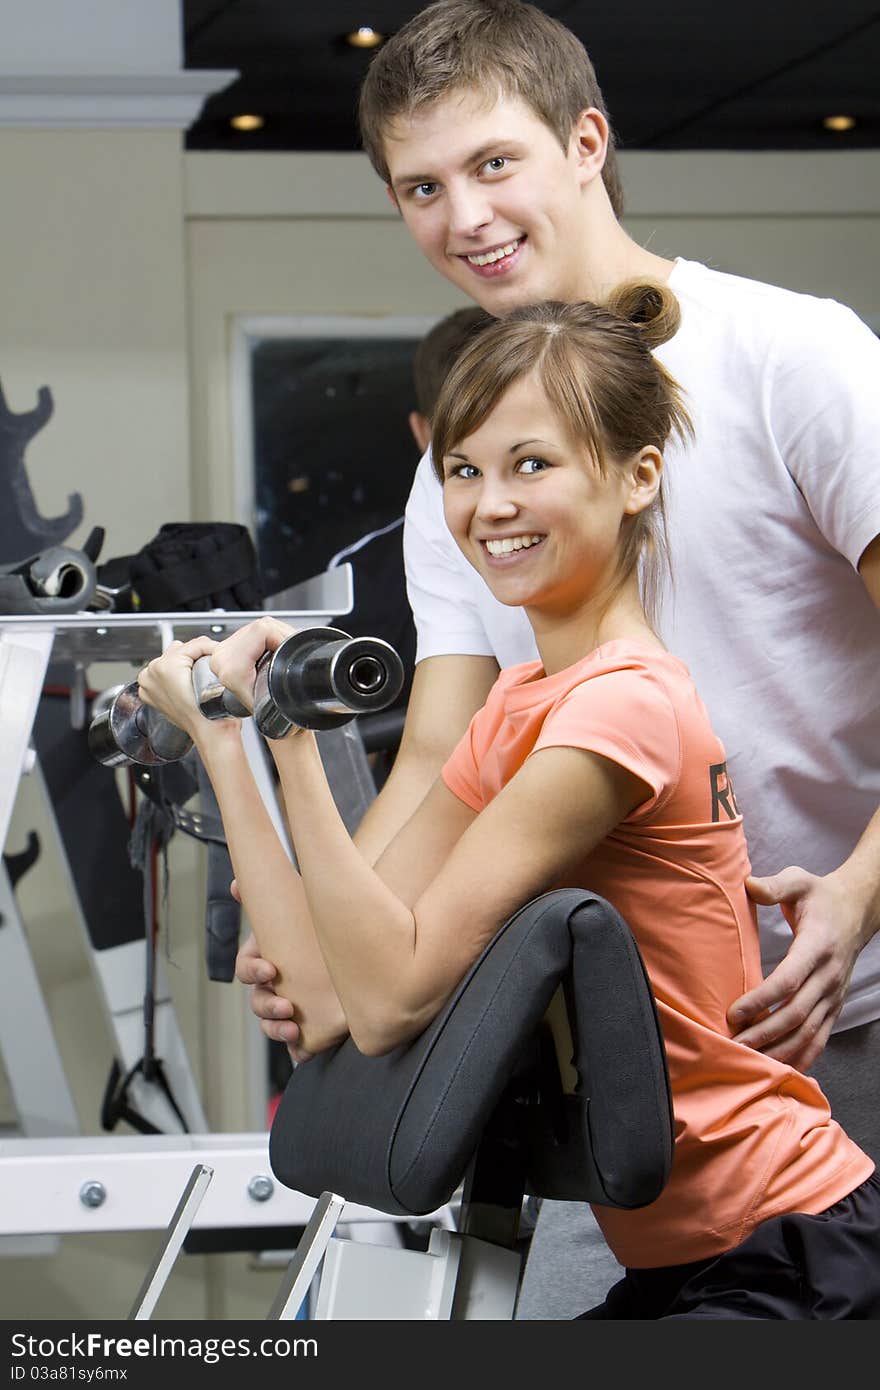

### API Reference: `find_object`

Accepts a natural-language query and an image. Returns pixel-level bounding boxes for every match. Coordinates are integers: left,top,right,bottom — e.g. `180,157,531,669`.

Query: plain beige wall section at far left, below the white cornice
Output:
0,129,189,559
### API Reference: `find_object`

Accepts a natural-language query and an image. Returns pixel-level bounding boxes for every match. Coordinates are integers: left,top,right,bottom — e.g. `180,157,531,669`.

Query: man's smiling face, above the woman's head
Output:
385,90,591,317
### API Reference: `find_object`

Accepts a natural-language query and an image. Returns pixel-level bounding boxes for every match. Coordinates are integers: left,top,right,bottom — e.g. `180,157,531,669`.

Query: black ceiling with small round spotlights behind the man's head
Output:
184,0,880,150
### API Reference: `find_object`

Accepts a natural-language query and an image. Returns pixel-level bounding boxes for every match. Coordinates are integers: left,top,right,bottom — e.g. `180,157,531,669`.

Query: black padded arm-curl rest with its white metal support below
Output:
268,888,673,1321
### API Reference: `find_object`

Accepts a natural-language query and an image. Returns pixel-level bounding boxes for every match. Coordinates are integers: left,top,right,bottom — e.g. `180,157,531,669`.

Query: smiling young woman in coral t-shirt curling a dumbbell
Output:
140,285,880,1319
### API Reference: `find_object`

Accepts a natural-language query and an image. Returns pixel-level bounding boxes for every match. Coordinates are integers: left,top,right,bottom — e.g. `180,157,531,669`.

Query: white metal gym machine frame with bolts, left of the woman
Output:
0,564,455,1318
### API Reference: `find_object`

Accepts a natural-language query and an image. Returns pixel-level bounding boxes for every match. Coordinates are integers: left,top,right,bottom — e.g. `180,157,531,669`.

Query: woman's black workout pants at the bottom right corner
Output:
581,1173,880,1321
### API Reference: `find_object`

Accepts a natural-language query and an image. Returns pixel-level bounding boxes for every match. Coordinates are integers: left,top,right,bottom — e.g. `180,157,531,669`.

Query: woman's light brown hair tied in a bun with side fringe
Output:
431,282,692,617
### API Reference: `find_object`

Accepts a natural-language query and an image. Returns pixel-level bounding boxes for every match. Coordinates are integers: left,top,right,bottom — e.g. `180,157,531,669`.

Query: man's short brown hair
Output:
359,0,623,217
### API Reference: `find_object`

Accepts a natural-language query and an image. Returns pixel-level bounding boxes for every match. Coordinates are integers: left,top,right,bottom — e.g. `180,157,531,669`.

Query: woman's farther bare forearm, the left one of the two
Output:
197,731,348,1052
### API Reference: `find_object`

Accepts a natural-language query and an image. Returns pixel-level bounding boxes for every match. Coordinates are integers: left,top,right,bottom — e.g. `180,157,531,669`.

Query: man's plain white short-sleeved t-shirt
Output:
405,260,880,1029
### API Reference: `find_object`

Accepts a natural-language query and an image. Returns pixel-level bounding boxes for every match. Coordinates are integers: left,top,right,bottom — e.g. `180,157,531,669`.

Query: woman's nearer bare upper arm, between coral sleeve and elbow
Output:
403,748,652,1017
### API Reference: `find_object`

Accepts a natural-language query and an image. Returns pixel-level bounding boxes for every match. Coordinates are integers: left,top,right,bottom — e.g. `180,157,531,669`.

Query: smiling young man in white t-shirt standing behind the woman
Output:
238,0,880,1316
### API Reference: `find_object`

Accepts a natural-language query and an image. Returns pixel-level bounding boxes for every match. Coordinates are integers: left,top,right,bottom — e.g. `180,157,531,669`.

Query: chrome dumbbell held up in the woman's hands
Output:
89,627,403,767
